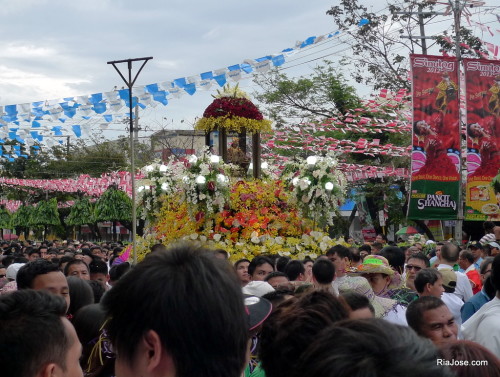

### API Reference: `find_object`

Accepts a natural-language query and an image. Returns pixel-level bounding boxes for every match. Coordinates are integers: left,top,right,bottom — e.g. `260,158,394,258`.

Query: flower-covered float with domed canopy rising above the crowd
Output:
137,88,346,261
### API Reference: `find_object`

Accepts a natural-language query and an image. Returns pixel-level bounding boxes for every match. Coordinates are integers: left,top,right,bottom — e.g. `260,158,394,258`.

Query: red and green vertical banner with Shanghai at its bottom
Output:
408,55,460,220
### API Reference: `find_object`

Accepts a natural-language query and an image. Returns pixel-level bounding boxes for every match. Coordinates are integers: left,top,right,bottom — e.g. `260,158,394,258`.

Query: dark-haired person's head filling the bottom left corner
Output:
0,290,83,377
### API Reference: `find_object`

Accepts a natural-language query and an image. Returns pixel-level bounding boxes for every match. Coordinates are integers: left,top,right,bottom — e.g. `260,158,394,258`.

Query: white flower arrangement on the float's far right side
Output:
282,154,347,225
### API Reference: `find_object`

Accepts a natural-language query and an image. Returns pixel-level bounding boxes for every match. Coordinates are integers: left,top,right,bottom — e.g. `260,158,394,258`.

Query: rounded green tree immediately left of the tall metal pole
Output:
95,186,132,240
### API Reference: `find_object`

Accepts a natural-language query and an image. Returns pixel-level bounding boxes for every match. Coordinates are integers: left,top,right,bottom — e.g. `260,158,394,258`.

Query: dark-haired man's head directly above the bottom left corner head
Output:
16,259,70,308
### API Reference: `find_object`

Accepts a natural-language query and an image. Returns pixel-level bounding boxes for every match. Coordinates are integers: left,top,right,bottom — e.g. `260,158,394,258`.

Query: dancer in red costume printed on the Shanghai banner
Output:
412,120,459,177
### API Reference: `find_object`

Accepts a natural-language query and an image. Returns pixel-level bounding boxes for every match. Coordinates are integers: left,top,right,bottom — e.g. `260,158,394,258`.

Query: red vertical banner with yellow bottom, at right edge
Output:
464,59,500,221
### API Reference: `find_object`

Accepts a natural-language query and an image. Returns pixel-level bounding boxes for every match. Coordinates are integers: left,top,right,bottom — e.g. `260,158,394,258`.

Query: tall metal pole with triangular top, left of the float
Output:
108,57,153,265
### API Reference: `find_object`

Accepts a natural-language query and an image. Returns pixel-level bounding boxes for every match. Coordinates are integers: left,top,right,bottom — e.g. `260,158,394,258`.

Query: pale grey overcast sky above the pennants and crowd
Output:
0,0,500,138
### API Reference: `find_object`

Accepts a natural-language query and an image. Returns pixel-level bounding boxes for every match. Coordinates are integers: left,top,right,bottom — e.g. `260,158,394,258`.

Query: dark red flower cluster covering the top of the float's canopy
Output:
203,97,264,120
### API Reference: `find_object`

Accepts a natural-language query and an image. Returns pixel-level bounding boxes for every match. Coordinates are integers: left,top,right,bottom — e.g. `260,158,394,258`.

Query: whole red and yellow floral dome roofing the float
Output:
195,86,272,133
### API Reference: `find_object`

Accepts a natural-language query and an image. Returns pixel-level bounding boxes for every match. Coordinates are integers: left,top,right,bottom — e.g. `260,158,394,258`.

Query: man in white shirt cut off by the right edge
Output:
462,255,500,357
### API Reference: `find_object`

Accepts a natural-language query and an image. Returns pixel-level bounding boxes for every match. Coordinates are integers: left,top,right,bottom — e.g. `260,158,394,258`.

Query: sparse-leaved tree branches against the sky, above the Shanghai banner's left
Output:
326,0,490,90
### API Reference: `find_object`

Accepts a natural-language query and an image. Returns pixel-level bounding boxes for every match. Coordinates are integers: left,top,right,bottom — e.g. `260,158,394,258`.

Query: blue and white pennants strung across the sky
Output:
0,19,370,160
